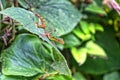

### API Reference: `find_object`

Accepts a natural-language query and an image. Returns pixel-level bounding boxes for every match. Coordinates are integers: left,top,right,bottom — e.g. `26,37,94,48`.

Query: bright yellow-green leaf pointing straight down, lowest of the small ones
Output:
71,47,87,65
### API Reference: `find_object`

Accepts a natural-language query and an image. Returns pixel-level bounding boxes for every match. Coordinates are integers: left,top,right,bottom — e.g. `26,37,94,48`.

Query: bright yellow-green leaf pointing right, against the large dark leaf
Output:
85,41,107,57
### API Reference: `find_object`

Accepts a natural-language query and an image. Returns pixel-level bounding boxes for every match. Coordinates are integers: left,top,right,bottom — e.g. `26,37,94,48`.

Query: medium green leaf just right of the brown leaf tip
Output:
63,34,81,48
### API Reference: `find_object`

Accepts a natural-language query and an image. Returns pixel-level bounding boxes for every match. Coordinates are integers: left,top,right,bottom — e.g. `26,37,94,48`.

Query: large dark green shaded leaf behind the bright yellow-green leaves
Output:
79,27,120,74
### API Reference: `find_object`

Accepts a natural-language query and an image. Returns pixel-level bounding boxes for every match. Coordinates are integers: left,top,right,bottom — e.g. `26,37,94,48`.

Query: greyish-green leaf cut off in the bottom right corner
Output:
103,71,120,80
